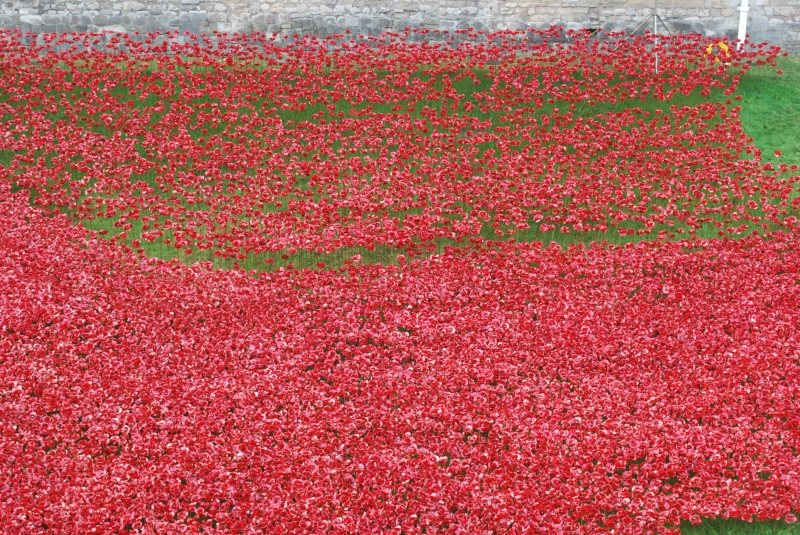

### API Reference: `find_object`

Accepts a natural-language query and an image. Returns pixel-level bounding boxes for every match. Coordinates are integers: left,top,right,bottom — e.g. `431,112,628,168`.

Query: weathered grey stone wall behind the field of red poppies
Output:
0,0,800,53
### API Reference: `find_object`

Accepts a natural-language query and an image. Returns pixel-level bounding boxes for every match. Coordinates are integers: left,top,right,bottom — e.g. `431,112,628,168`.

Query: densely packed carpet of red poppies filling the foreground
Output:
0,183,800,534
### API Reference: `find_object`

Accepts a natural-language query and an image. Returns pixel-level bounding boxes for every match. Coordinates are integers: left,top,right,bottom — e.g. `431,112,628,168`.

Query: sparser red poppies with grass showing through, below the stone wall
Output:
0,31,800,259
